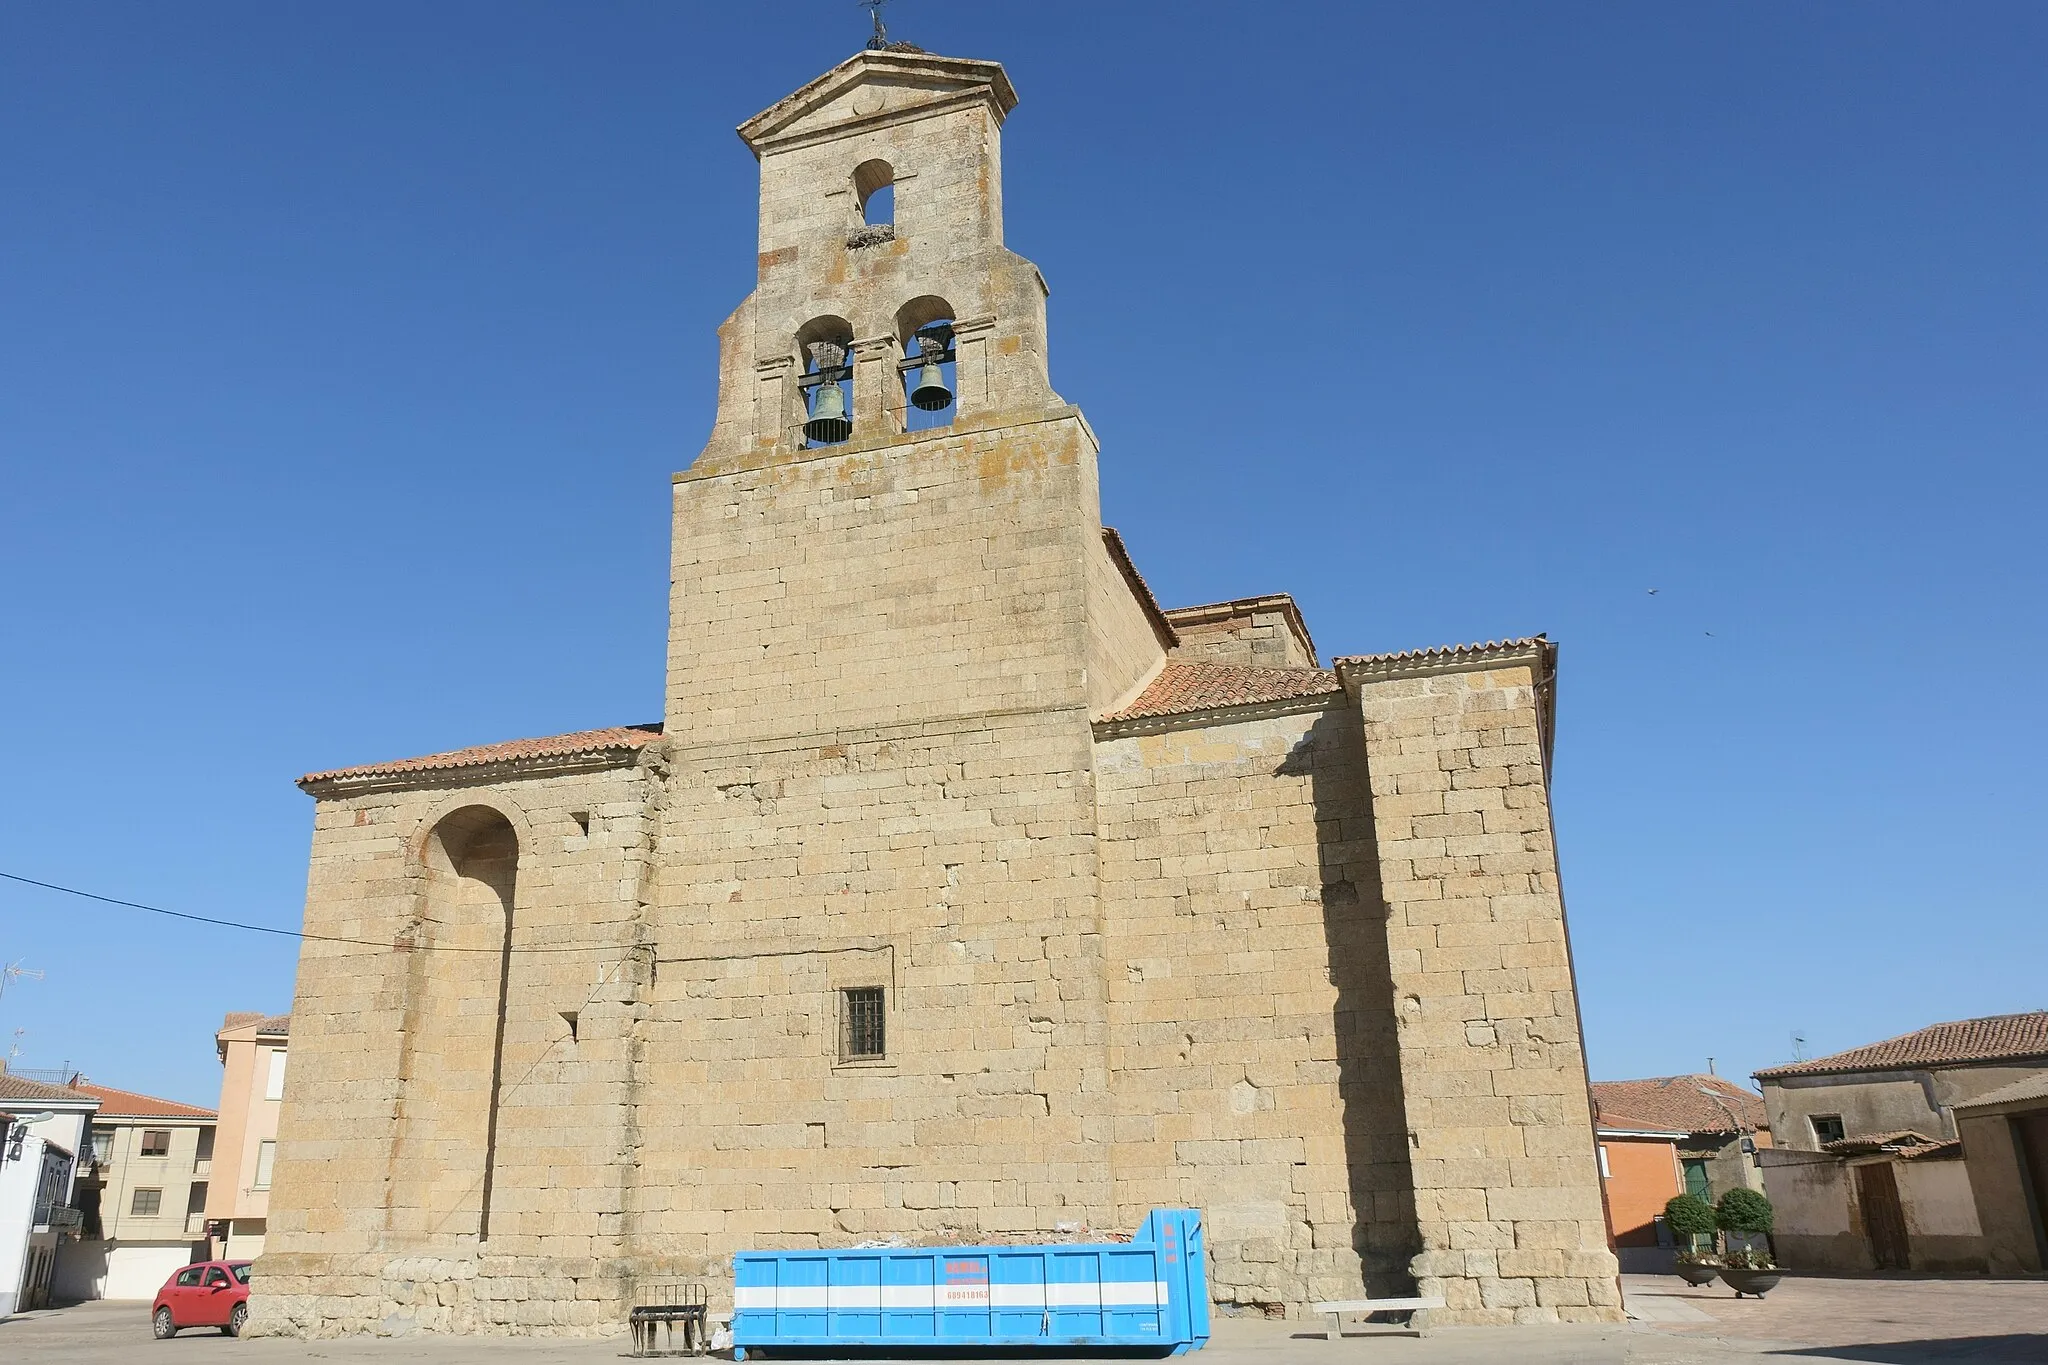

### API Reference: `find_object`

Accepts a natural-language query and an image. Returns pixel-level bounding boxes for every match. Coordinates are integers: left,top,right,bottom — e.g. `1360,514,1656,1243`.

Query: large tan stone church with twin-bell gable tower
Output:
252,45,1620,1334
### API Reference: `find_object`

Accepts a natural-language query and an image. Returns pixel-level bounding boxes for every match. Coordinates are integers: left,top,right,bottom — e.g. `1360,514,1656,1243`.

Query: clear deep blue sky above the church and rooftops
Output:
0,0,2048,1101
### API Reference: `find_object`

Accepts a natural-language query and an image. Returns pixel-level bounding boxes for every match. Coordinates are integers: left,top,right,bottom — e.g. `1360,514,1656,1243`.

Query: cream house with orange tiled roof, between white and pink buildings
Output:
55,1078,215,1300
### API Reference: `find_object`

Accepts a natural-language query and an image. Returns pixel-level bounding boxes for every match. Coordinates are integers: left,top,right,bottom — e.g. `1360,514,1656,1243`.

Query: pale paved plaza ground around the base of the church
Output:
0,1275,2048,1365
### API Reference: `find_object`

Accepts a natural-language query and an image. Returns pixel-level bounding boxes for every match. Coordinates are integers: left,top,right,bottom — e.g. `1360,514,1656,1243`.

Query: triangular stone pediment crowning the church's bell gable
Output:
739,49,1018,156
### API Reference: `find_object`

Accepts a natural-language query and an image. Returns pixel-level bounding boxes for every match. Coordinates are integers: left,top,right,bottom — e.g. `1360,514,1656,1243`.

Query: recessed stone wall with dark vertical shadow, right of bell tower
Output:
1096,704,1413,1306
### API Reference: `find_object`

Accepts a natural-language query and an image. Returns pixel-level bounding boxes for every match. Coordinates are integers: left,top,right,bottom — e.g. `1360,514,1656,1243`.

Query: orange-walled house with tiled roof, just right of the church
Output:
1593,1076,1772,1273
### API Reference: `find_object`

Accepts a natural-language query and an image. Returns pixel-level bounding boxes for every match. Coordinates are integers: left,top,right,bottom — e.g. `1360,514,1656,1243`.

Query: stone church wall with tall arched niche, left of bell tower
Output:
250,767,647,1334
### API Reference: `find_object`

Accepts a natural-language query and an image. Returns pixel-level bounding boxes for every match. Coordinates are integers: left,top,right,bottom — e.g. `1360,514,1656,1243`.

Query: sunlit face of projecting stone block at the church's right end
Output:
1358,665,1620,1324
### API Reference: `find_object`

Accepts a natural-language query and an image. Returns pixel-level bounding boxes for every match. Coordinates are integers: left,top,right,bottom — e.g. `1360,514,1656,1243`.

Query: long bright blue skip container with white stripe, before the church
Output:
733,1209,1208,1361
